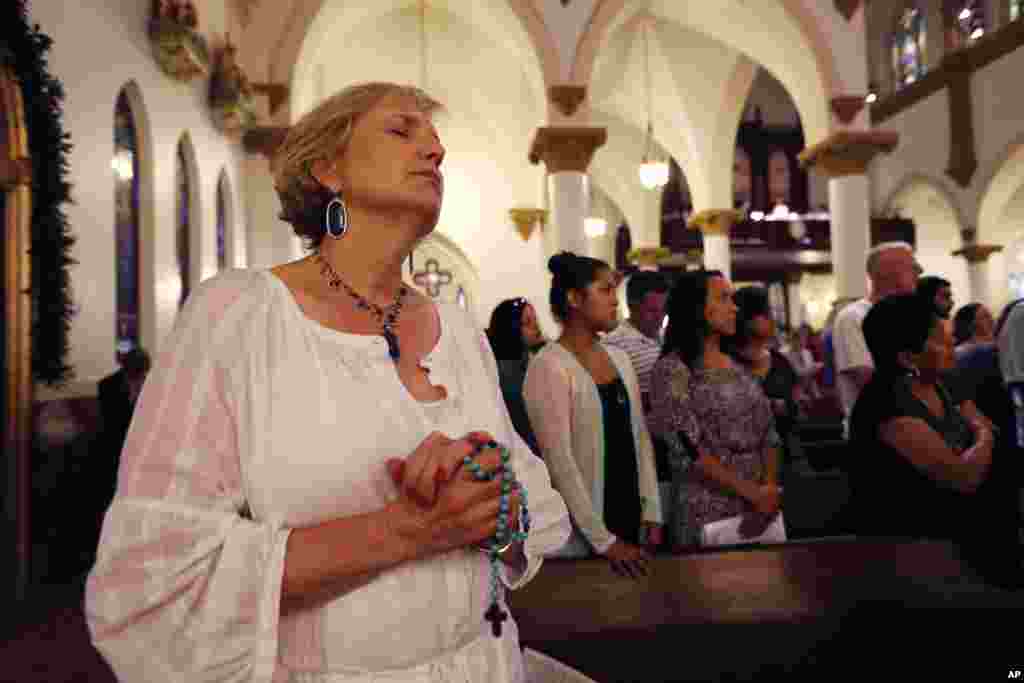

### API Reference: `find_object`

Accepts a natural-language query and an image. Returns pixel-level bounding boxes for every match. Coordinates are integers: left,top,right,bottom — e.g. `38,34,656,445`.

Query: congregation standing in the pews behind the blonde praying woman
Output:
489,243,1024,586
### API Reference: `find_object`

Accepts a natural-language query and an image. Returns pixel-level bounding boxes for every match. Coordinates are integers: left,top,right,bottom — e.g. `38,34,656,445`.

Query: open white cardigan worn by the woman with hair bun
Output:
523,343,663,557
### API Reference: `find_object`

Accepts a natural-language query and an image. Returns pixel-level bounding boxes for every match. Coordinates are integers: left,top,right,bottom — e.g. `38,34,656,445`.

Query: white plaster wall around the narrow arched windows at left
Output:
30,0,245,398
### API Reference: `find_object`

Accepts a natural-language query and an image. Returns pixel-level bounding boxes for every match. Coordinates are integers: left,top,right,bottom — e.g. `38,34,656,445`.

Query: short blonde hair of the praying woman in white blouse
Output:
271,82,442,249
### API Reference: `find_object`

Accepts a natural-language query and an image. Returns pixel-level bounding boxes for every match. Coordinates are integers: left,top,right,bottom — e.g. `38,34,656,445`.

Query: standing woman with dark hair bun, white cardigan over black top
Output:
524,252,662,577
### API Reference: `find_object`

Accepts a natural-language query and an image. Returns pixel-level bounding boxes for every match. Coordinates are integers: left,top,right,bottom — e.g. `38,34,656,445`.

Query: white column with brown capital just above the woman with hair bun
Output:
529,126,607,254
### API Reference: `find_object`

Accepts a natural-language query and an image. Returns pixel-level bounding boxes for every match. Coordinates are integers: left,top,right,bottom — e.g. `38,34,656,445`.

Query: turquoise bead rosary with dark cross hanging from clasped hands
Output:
463,441,529,638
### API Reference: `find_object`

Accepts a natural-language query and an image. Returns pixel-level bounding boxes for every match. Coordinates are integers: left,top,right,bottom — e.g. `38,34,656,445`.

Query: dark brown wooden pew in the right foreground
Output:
509,539,1024,683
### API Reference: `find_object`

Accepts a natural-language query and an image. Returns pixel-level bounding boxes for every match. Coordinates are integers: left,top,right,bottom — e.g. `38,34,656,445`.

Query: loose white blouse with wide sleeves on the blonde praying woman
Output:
86,270,569,683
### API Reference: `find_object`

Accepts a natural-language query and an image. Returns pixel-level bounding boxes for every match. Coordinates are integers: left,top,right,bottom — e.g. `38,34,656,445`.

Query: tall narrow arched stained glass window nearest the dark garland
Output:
111,90,139,358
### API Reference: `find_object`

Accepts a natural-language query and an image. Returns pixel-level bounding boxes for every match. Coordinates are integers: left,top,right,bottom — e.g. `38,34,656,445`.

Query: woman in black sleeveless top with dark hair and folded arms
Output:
849,295,992,539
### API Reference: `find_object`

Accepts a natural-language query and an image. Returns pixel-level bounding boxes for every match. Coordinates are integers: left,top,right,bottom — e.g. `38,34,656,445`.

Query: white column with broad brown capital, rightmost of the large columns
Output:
800,130,899,303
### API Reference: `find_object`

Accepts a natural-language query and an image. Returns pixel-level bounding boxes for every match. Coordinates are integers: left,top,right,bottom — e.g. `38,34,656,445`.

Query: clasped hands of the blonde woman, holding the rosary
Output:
387,432,519,558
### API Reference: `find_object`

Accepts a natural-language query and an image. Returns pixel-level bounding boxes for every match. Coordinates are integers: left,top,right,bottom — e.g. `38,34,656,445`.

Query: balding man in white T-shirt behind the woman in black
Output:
833,242,921,430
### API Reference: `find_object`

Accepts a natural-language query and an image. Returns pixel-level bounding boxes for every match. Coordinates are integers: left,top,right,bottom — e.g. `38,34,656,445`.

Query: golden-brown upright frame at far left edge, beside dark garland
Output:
0,62,33,598
